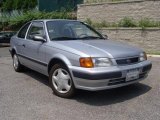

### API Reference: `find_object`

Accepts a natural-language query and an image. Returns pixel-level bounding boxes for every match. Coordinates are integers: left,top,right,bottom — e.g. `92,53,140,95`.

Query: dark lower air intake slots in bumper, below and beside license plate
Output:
108,73,146,86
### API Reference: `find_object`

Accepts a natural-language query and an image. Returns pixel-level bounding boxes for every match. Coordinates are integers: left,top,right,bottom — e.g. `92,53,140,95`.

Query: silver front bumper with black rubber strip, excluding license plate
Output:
70,61,152,91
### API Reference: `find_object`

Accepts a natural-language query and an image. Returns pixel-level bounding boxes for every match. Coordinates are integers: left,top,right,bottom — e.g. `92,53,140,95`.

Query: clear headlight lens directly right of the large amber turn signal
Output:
93,58,112,67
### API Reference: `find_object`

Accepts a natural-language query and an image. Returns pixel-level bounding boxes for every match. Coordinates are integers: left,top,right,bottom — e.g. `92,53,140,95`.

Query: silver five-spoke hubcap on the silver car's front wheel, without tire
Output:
52,68,71,93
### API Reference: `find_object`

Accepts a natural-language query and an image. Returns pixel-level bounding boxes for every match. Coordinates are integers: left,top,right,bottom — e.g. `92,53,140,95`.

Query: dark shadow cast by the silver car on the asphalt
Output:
24,69,152,106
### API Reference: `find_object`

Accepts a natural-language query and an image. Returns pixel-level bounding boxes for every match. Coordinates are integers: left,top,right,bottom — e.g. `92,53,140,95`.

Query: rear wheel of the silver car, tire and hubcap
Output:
13,53,23,72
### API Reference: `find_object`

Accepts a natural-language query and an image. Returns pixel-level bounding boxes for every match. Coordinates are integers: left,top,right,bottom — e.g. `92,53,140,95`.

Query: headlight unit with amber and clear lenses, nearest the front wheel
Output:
79,58,112,68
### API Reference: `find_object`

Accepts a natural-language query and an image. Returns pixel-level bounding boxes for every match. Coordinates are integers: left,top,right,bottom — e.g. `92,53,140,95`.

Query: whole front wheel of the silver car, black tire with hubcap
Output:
49,64,75,98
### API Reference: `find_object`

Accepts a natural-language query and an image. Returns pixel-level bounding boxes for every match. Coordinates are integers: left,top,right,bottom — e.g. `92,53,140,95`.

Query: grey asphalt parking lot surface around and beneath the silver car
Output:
0,47,160,120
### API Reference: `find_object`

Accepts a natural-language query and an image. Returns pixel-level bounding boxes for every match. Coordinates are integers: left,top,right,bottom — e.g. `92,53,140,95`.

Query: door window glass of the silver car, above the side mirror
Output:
27,22,45,40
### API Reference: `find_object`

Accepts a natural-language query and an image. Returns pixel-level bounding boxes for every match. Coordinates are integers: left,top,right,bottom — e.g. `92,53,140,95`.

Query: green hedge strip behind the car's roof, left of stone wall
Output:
0,10,76,30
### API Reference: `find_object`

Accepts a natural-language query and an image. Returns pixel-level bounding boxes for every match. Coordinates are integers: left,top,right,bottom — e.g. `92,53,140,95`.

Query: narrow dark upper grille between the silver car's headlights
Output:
116,57,139,65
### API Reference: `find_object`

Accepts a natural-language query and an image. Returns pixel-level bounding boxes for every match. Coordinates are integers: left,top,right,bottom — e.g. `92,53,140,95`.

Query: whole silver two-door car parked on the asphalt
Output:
10,20,152,98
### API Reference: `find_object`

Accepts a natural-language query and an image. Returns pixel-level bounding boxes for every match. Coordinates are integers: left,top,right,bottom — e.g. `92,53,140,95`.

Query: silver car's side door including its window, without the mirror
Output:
24,21,47,74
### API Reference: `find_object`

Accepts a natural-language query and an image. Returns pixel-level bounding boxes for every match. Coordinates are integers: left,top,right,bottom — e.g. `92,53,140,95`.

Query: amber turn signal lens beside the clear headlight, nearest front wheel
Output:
79,57,94,68
